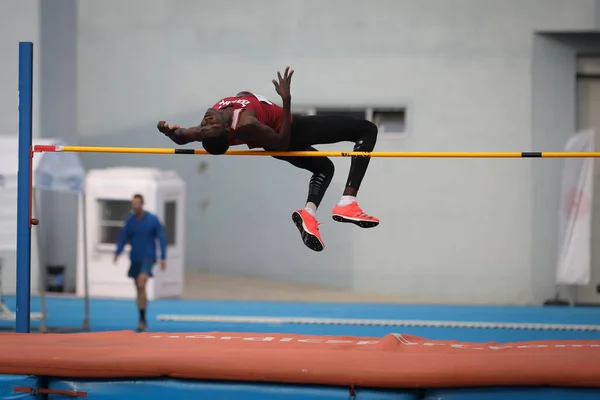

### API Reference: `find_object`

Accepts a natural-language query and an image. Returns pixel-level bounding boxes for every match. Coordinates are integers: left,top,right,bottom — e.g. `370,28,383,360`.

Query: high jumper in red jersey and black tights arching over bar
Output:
158,67,379,251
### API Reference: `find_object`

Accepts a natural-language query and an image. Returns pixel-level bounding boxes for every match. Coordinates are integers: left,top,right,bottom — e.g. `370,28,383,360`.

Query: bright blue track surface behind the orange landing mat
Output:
0,296,600,343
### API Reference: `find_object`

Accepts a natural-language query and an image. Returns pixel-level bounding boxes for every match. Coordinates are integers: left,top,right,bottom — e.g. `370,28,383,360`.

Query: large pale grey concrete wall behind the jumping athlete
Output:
4,0,600,303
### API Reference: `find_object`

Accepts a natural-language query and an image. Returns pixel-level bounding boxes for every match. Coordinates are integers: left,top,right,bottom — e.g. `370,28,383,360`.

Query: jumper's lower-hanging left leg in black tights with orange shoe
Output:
275,147,335,251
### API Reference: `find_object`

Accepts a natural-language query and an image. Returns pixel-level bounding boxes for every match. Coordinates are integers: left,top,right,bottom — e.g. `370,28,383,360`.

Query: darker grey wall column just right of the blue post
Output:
36,0,78,291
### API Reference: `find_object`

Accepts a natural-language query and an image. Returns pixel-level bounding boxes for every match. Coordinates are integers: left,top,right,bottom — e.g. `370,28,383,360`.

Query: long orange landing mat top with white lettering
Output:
0,331,600,388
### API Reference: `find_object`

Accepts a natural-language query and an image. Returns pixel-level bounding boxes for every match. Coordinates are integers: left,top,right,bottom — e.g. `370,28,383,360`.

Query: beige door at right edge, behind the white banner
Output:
575,58,600,304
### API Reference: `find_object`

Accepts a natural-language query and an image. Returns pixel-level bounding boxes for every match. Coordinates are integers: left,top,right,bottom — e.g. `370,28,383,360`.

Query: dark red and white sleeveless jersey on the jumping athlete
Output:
213,92,290,148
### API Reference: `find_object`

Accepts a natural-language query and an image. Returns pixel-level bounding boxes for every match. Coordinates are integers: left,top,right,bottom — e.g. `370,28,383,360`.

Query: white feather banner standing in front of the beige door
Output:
556,130,595,285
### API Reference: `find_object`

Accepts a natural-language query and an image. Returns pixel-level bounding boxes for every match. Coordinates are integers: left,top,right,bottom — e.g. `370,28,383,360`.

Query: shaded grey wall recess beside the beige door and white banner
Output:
531,33,600,300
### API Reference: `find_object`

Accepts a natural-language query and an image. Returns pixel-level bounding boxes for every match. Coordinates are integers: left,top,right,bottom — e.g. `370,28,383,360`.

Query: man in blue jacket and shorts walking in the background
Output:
115,194,167,331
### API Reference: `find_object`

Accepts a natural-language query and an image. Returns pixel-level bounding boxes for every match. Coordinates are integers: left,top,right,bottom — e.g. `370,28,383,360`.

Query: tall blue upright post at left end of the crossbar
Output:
16,42,33,333
